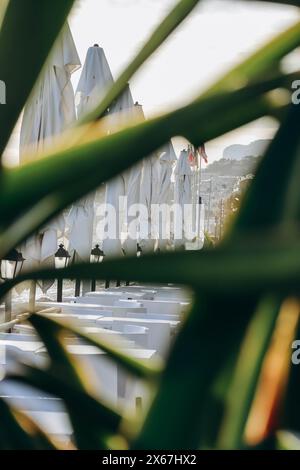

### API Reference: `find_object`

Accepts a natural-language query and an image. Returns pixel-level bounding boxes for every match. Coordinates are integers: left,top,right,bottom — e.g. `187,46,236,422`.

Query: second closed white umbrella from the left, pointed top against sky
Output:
67,44,113,261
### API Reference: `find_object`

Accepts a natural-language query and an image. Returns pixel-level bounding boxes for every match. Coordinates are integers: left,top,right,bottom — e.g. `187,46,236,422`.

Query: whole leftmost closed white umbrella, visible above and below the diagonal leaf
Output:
20,24,81,291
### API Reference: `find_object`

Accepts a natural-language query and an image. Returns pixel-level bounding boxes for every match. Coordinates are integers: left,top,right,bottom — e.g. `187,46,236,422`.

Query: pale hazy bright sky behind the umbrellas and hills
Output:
3,0,298,165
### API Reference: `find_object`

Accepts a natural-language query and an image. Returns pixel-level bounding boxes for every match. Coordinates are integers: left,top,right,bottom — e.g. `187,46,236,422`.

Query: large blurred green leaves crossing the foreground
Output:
0,0,300,449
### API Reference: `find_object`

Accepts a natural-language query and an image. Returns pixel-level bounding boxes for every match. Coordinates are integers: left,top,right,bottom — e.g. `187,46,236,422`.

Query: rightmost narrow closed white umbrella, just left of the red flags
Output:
175,150,194,247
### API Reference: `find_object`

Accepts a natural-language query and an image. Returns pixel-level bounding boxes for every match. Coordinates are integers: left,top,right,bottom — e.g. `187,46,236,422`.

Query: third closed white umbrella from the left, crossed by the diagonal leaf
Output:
103,85,142,256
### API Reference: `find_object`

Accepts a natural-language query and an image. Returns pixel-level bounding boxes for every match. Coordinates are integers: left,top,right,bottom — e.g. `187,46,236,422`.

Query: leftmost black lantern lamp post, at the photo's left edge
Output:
1,249,25,323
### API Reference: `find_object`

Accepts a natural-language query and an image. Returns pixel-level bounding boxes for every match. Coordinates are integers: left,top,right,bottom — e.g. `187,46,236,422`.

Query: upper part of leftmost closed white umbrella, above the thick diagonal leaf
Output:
20,24,81,163
